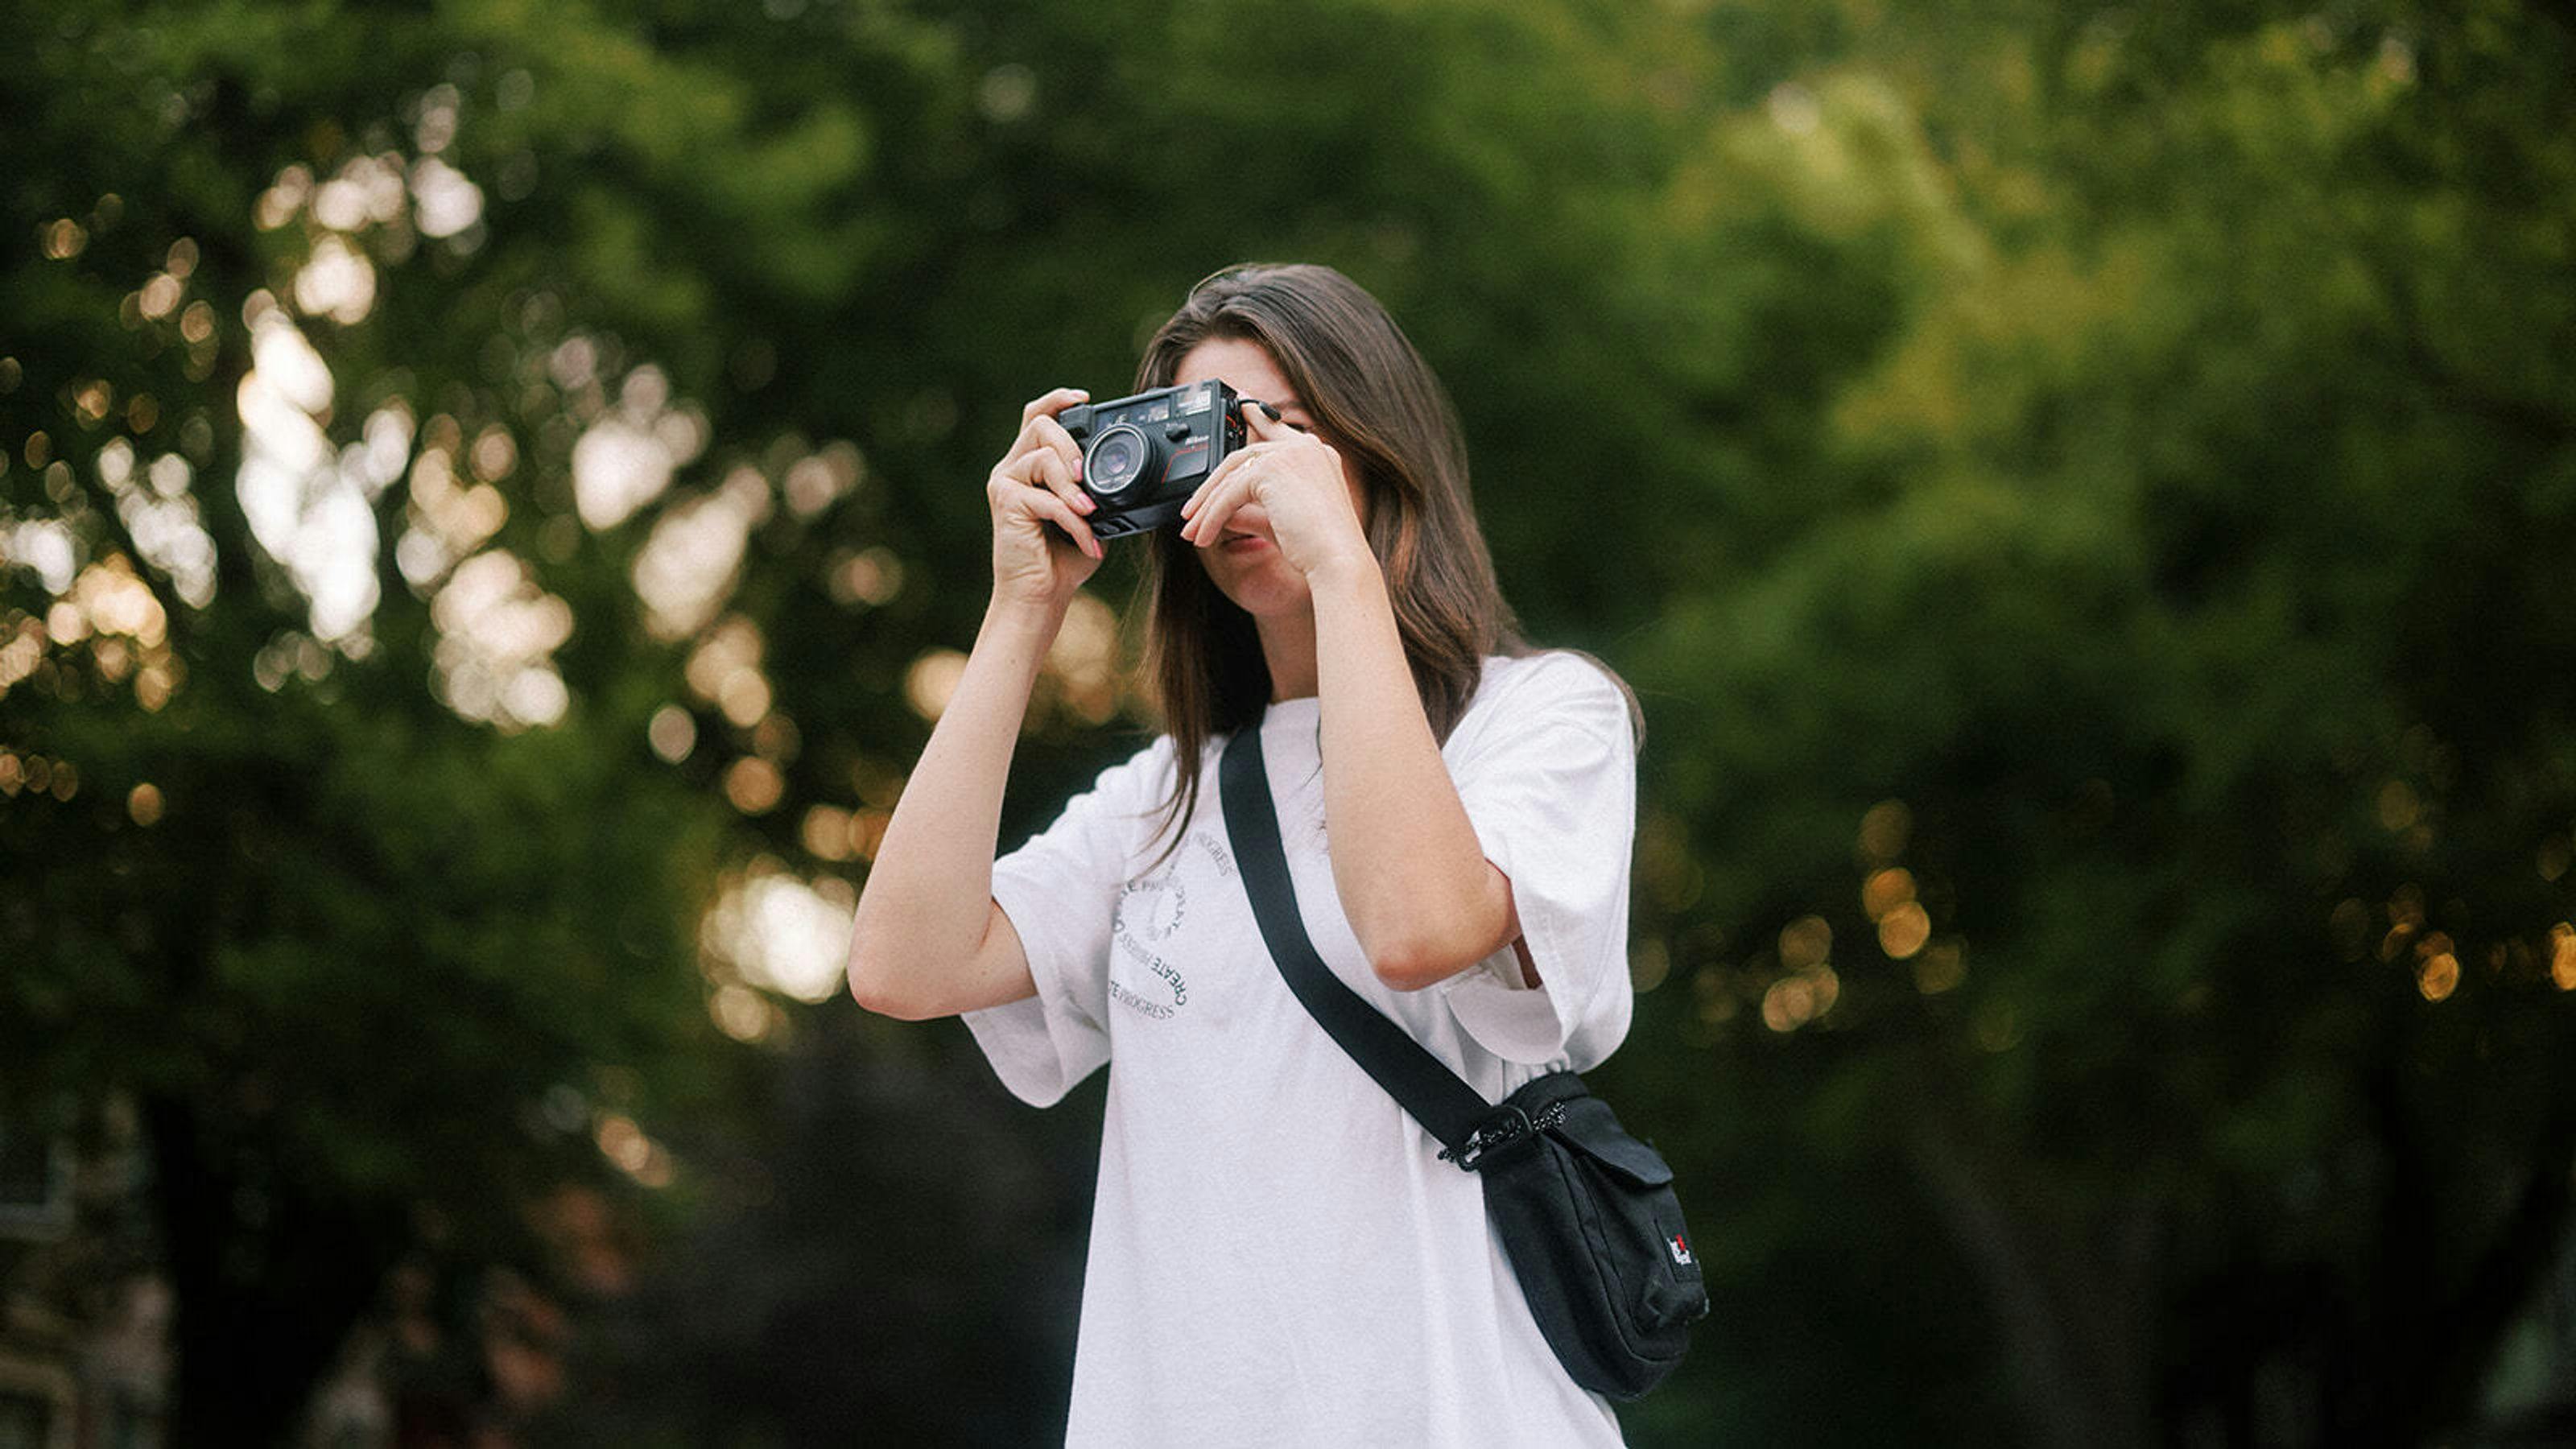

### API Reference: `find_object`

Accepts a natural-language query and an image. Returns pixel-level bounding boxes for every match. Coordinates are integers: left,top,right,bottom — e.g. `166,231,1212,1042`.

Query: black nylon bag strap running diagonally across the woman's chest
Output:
1216,720,1494,1153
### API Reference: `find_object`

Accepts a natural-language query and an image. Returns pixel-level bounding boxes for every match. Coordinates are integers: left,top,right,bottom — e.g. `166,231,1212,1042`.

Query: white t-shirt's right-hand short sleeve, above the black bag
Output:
1443,655,1636,1070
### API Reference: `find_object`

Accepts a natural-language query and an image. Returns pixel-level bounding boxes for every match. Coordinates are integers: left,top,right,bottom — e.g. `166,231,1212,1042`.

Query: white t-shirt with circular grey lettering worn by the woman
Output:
966,655,1636,1449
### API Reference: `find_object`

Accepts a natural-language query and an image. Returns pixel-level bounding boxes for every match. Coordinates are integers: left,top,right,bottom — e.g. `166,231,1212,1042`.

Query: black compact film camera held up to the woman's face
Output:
1056,379,1245,539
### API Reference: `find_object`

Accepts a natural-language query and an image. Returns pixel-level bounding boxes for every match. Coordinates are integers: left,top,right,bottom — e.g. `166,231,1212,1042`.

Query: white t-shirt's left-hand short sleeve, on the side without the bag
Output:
964,737,1172,1106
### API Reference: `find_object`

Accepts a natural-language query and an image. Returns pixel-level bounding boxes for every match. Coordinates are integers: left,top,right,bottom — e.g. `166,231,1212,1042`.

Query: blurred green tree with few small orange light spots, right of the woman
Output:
1633,5,2576,1444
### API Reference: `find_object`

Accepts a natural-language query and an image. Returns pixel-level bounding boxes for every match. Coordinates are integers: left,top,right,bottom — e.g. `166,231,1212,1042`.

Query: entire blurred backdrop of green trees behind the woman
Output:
0,0,2576,1449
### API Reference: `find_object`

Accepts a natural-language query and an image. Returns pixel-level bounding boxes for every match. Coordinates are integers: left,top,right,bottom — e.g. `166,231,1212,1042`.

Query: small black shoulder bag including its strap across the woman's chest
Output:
1219,722,1708,1400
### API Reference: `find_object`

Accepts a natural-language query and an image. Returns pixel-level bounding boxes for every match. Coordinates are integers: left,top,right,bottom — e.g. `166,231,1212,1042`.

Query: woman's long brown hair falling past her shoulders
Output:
1136,263,1530,853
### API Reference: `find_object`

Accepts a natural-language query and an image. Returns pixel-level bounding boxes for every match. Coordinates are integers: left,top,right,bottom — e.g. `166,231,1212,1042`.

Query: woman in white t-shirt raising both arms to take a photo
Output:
850,266,1636,1447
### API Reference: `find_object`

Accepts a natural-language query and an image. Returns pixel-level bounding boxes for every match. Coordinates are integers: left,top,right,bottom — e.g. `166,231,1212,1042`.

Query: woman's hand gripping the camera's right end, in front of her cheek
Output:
1180,399,1376,577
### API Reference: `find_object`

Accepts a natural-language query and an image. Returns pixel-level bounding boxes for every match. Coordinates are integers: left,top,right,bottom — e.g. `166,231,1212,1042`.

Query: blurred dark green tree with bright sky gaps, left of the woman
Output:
0,2,937,1444
